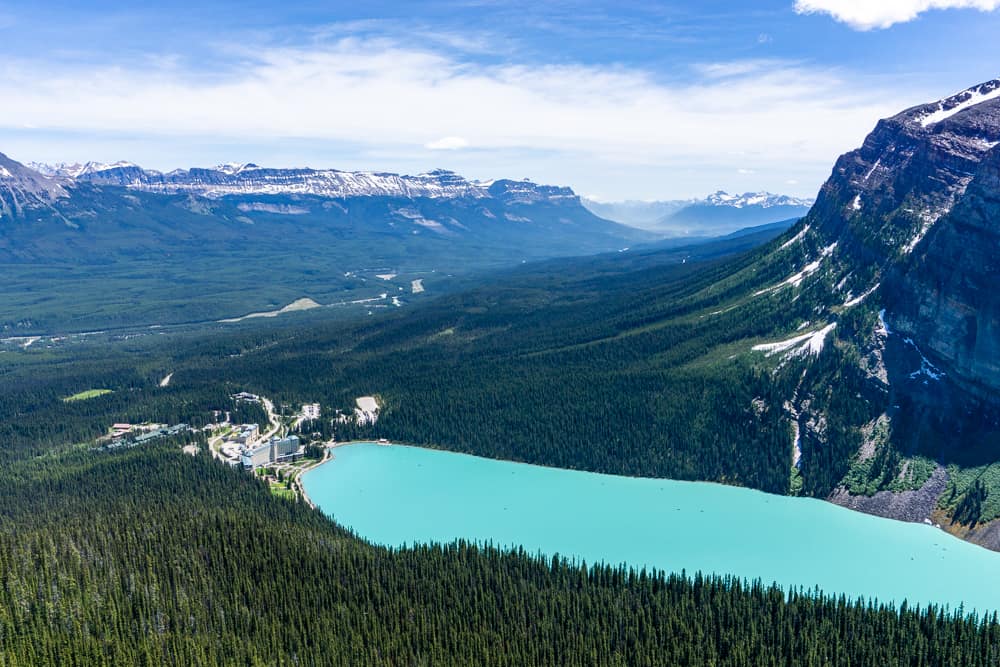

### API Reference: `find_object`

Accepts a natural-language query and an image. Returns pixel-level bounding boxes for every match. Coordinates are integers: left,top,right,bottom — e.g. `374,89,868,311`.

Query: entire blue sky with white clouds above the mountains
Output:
0,0,1000,200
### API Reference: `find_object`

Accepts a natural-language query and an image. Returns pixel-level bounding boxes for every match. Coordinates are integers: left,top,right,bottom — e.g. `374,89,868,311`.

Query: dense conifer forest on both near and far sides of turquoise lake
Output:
0,228,1000,666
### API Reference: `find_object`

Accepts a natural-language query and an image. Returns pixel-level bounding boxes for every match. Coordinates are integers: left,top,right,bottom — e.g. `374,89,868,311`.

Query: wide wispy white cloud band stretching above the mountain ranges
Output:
0,39,922,197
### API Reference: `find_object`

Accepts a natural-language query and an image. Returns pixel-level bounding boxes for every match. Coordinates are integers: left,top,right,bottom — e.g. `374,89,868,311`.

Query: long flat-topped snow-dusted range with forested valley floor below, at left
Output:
0,158,654,333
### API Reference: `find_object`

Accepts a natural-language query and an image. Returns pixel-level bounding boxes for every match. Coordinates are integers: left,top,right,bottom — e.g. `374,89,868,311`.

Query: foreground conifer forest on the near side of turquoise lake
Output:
0,444,1000,667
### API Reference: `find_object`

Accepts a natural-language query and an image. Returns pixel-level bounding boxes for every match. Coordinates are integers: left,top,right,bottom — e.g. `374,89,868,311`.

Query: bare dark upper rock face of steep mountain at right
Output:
788,80,1000,402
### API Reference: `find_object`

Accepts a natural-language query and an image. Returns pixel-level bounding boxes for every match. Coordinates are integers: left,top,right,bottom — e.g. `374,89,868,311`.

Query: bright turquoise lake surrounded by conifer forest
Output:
303,444,1000,611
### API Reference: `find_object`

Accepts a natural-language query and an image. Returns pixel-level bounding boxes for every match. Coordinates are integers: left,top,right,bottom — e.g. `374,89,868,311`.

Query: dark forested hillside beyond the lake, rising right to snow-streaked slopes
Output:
2,180,998,540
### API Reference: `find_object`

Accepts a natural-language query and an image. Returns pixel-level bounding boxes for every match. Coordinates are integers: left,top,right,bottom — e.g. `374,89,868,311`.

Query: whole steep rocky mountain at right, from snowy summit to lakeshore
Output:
716,81,1000,548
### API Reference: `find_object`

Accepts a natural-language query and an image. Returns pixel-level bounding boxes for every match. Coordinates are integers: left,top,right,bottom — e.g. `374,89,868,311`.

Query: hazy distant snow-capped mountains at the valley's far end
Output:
582,190,815,236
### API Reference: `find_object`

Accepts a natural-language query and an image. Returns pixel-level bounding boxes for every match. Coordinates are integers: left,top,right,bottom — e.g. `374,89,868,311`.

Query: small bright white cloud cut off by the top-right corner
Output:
795,0,1000,30
